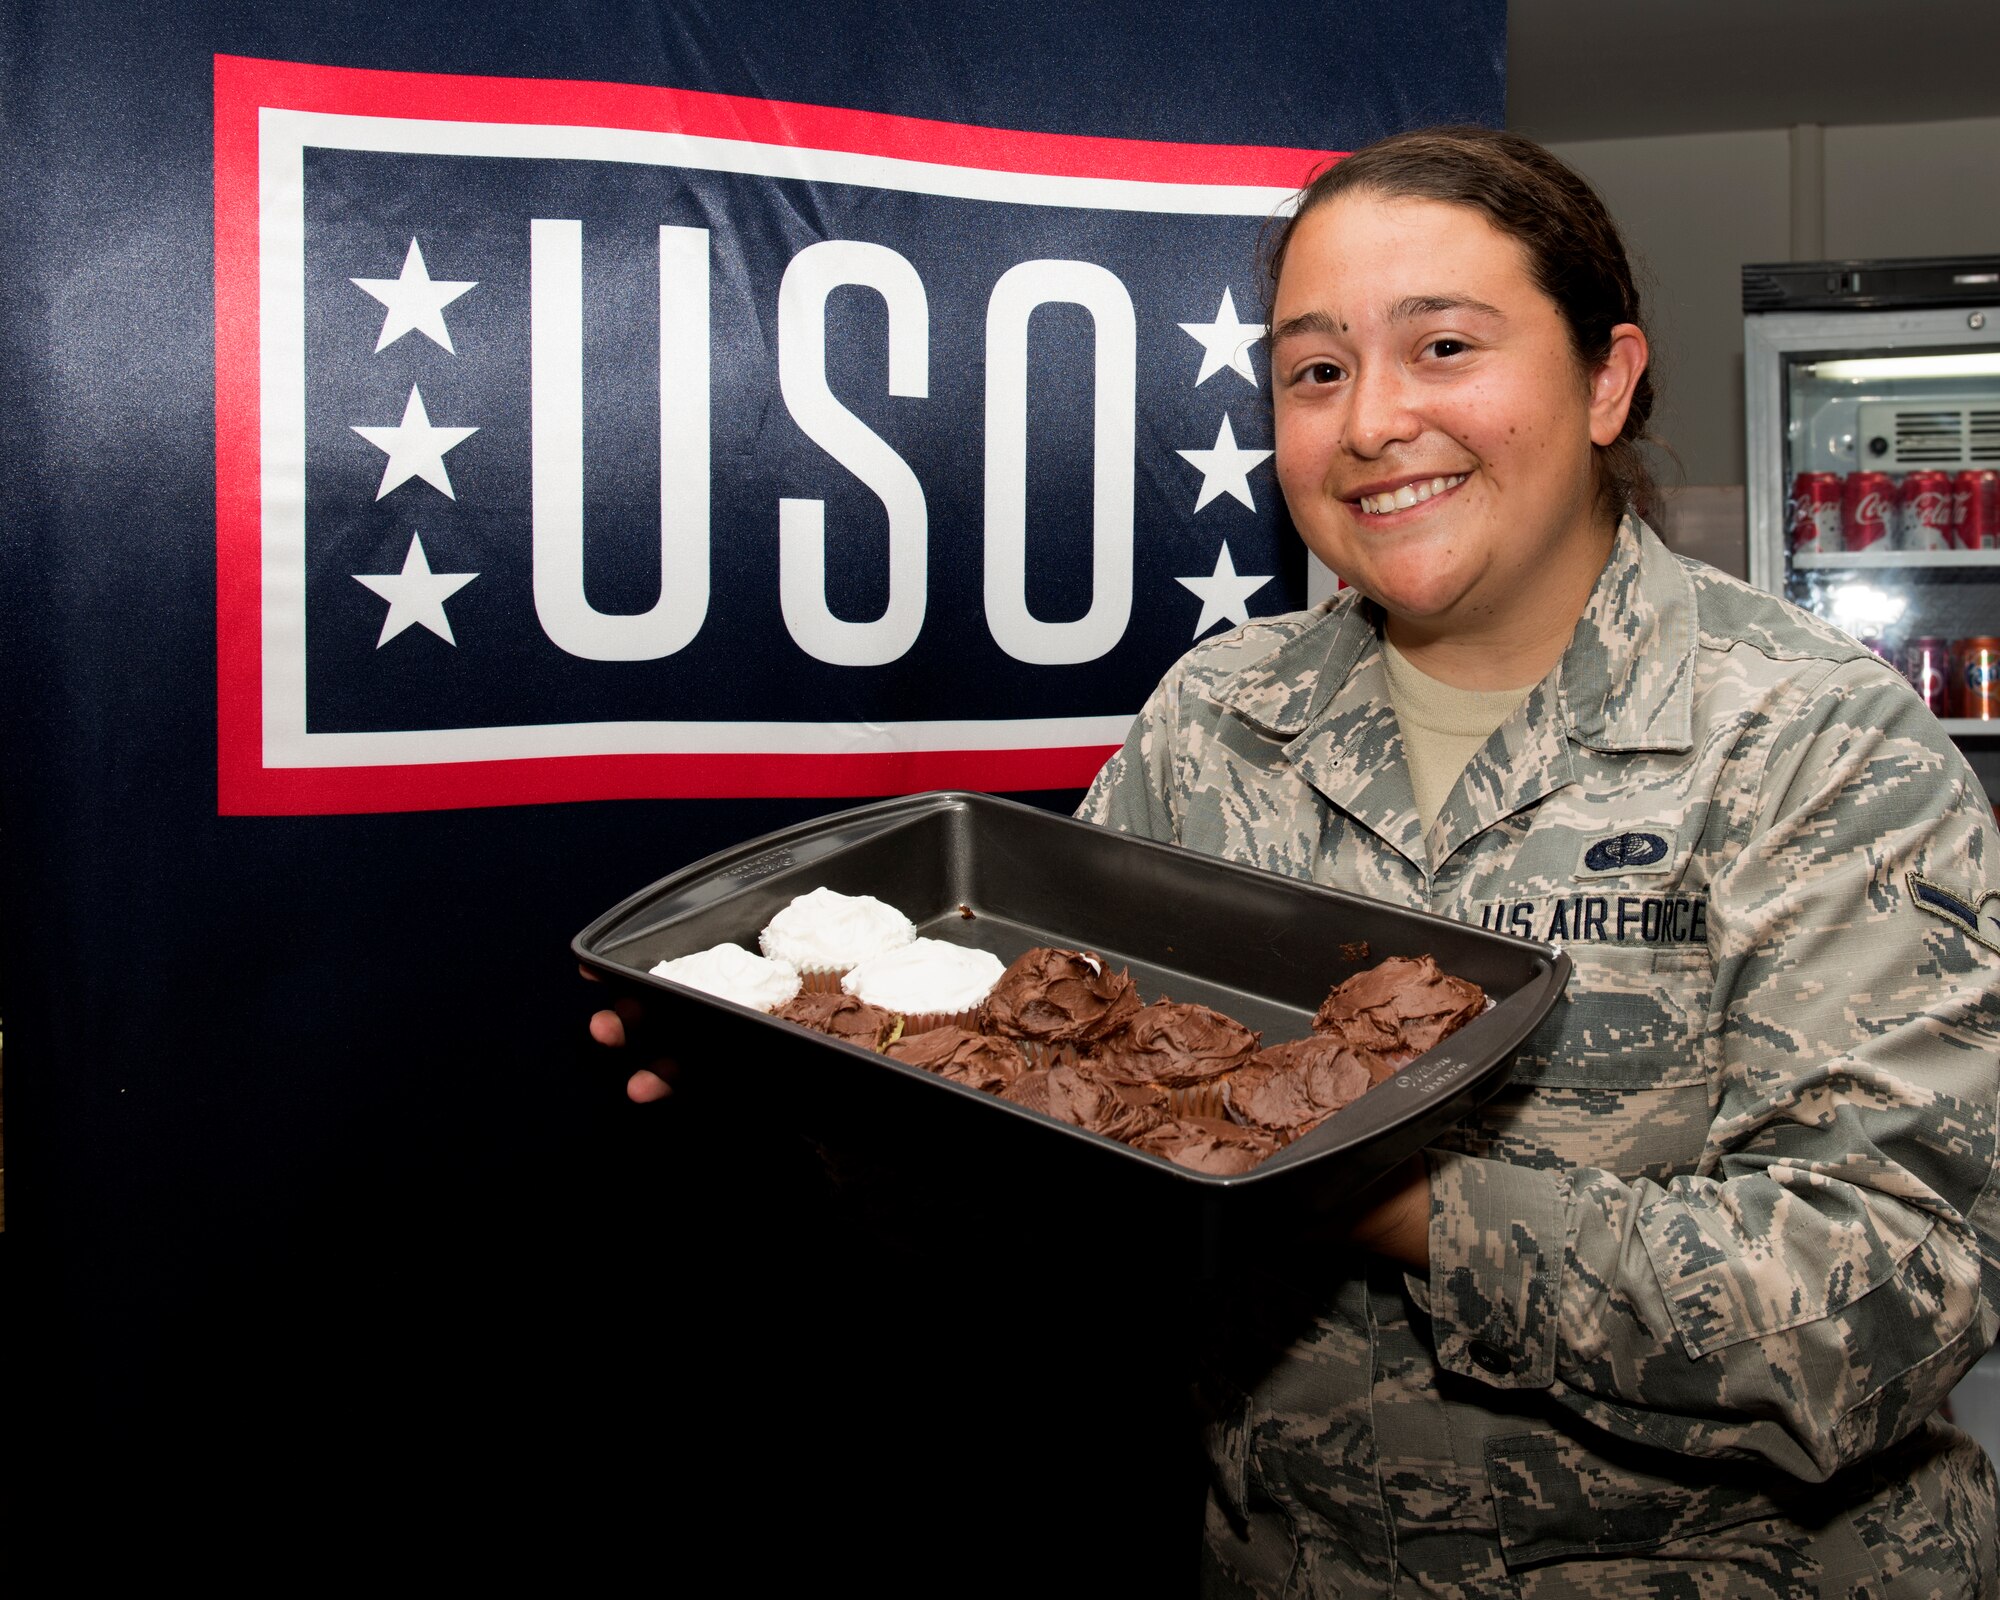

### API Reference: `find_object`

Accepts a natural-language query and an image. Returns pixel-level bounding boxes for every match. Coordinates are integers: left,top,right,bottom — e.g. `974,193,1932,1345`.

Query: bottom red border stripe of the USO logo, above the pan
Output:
220,744,1118,816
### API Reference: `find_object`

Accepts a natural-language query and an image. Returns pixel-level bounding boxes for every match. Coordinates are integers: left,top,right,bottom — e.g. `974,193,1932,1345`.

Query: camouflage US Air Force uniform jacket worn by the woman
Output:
1078,518,2000,1600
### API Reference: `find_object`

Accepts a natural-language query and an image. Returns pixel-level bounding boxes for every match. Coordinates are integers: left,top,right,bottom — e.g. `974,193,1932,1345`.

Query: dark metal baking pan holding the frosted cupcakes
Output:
572,792,1570,1264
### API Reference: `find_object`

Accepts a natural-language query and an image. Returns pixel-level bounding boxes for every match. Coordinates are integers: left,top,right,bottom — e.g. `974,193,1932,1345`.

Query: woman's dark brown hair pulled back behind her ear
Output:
1264,126,1658,516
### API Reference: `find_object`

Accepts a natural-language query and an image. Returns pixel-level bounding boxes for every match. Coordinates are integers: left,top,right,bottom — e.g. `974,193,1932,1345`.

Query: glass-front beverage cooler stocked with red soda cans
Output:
1742,256,2000,794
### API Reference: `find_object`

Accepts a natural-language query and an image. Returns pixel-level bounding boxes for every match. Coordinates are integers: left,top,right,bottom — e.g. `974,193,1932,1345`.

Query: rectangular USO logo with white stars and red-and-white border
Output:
216,56,1324,812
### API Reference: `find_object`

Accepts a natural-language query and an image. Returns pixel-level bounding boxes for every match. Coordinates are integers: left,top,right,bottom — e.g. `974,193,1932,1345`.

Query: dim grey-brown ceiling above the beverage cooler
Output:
1506,0,2000,144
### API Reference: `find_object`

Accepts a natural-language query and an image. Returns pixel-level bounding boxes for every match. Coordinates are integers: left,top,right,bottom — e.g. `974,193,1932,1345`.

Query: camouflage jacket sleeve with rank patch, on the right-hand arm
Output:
1428,662,2000,1480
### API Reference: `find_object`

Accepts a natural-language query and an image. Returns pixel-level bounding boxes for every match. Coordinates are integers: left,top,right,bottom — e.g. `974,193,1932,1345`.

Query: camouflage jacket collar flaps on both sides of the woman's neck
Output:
1222,516,1696,750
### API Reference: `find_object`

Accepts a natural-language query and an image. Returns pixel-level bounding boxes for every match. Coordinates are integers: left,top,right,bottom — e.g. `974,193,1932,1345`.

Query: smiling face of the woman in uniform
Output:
1272,190,1646,686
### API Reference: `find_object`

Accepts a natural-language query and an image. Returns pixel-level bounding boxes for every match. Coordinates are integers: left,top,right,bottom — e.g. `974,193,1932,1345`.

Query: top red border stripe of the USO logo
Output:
216,56,1344,188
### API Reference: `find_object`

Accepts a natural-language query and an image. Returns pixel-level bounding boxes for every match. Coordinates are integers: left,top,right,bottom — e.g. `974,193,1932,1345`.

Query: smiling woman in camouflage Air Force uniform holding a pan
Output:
1080,130,2000,1598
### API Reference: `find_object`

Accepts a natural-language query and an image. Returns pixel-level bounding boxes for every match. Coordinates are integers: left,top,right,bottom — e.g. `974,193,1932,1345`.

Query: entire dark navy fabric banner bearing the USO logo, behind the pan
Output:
0,0,1506,1528
